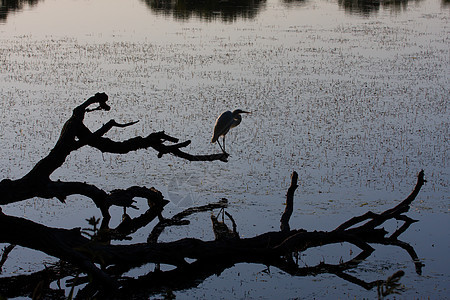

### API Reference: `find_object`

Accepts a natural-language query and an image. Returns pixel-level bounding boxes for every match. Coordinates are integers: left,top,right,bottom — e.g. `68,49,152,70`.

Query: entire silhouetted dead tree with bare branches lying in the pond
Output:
0,94,425,299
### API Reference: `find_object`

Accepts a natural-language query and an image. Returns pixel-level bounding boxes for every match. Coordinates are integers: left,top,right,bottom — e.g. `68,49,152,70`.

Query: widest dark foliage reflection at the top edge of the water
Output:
143,0,266,22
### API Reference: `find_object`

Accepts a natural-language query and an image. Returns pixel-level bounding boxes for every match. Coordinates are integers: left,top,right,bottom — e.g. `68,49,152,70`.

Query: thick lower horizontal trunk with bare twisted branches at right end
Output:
0,172,425,296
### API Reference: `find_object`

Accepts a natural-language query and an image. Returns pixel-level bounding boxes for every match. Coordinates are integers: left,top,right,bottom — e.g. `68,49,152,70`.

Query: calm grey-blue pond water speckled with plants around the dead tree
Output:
0,0,450,299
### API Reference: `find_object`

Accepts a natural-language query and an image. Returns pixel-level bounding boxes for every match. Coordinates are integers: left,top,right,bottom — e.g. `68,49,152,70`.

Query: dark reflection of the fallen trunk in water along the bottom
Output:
0,239,418,299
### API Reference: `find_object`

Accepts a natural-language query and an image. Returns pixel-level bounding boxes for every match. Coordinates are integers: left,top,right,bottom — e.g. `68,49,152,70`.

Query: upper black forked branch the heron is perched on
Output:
0,93,228,223
